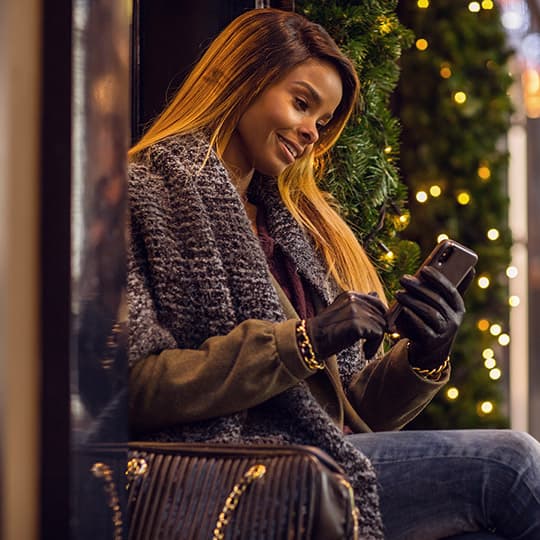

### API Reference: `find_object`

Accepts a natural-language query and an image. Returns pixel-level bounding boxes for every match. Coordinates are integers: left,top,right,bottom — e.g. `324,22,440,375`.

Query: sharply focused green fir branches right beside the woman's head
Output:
296,0,419,296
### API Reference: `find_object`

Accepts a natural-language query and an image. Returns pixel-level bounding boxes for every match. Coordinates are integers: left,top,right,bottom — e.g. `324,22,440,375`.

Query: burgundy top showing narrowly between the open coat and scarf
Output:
257,206,315,319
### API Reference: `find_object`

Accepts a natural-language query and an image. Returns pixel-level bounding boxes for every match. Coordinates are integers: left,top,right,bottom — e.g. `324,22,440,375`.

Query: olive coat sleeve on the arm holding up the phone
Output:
347,339,450,431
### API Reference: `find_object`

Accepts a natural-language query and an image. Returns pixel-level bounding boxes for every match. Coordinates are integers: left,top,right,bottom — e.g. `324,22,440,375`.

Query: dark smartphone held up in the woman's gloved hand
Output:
387,239,478,332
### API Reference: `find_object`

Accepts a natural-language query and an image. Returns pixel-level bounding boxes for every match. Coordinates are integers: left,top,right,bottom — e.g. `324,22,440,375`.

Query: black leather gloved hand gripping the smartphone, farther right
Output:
390,266,475,369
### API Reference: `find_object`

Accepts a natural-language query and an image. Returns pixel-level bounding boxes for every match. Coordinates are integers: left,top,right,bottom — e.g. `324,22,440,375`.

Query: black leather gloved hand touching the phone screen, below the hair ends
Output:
306,291,386,358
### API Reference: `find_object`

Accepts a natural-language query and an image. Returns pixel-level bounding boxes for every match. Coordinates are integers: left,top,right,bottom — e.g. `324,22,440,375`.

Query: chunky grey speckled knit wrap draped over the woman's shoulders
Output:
128,135,383,539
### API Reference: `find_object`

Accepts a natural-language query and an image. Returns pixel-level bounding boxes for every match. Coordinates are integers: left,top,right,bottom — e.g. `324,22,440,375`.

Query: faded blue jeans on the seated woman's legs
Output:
347,430,540,540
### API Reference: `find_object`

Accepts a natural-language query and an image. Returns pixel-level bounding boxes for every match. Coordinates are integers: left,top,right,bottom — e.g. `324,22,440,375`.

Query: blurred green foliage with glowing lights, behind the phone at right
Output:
395,0,512,428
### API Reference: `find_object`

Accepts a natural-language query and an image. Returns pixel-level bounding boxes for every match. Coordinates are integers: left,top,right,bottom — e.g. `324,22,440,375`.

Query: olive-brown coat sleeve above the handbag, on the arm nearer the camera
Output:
129,319,313,431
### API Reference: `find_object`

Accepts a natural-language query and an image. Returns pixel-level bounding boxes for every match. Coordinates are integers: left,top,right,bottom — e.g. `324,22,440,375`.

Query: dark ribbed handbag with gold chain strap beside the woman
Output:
126,442,359,540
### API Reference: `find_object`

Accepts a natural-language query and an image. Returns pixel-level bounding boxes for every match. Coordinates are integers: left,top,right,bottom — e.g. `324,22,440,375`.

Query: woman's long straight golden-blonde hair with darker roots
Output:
129,9,384,298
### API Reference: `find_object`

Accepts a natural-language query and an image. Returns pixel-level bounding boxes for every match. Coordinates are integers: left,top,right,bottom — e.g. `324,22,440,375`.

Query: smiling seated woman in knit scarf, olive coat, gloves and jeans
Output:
128,9,540,539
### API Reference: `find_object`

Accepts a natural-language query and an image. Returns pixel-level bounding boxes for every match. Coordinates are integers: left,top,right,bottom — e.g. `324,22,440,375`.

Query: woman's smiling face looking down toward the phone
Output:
223,59,342,176
